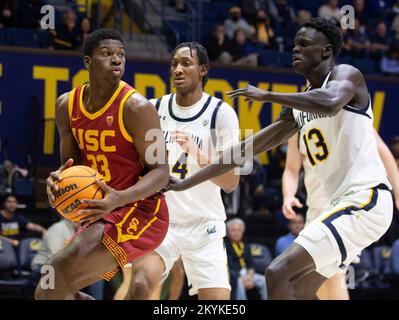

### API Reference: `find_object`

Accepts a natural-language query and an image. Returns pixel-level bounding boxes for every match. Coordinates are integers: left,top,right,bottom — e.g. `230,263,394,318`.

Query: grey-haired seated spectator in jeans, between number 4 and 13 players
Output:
225,218,267,300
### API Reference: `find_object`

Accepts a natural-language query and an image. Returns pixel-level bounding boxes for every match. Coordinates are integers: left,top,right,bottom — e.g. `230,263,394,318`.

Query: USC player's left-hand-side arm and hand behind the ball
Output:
46,92,80,207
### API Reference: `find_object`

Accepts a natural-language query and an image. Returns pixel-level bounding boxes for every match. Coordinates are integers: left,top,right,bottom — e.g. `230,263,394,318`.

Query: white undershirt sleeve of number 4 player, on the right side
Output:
216,102,240,151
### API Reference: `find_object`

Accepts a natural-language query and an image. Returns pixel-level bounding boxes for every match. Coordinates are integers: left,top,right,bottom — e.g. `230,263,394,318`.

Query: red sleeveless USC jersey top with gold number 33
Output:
68,81,143,190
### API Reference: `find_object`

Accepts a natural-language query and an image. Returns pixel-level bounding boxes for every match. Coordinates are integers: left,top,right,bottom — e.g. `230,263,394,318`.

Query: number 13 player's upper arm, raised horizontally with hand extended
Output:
227,65,364,116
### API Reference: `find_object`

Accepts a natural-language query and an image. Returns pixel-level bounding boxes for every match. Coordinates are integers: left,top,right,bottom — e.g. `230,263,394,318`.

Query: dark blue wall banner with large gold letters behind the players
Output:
0,48,399,165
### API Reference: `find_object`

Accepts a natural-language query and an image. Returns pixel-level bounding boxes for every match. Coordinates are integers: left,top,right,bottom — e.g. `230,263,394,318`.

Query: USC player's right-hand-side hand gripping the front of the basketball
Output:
79,180,126,226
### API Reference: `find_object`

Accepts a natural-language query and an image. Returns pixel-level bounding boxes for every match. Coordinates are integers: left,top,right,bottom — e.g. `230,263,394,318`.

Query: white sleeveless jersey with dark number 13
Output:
293,72,391,201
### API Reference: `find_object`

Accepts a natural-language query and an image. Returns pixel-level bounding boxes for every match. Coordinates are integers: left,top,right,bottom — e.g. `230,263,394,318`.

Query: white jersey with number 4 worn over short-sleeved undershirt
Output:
151,93,239,223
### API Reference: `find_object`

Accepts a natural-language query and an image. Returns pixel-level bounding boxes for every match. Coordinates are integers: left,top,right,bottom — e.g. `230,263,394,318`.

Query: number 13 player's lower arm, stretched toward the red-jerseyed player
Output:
166,109,298,191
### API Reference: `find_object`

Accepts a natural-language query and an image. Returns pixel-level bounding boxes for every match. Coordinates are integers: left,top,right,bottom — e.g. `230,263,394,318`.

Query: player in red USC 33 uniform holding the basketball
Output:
35,29,169,299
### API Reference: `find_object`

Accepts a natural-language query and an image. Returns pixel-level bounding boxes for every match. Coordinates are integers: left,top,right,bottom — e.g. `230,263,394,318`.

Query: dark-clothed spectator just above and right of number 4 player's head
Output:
204,24,231,63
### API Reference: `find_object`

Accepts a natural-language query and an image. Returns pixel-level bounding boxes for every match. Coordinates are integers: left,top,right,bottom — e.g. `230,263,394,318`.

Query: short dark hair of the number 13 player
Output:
301,17,344,57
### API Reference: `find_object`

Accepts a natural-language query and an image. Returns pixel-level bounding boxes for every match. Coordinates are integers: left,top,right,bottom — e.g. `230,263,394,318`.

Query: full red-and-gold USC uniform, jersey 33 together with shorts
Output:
68,81,169,279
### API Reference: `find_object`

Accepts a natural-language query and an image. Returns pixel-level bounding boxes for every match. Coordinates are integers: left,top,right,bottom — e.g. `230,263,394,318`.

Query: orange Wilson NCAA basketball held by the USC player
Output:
54,166,104,222
